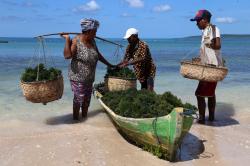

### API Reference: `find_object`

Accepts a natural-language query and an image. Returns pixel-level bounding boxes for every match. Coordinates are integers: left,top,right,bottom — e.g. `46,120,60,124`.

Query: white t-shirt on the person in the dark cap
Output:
200,25,223,66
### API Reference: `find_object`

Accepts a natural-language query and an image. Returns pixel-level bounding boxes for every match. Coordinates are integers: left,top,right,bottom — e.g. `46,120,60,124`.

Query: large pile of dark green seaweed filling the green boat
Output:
102,89,197,118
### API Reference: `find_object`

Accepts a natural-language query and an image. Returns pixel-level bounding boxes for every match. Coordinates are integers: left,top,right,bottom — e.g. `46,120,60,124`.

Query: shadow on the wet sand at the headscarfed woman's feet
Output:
45,109,103,125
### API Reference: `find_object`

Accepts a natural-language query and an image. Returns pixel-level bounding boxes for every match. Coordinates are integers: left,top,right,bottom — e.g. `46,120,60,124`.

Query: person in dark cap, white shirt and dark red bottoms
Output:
191,10,223,124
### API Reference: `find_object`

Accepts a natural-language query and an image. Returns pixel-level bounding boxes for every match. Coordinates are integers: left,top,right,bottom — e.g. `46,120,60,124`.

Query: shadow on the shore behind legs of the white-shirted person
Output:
206,103,239,127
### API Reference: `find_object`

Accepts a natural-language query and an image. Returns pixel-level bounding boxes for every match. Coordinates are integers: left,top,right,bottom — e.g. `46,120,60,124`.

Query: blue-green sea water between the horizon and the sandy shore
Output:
0,35,250,121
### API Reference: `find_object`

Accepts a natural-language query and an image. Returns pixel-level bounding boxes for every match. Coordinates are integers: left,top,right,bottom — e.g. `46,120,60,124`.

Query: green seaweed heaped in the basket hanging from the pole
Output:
21,63,62,82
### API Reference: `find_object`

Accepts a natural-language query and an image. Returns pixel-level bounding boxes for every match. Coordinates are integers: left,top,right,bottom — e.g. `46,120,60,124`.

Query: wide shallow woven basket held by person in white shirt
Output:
180,60,228,82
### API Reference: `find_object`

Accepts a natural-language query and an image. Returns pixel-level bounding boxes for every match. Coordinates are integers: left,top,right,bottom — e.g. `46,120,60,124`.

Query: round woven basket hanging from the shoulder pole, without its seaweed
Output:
21,76,63,104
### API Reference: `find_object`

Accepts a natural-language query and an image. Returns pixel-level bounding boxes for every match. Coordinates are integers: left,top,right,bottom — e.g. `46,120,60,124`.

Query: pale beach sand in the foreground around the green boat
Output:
0,99,250,166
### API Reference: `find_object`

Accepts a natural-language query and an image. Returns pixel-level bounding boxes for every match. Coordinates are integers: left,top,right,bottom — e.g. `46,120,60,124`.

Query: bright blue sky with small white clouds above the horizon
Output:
0,0,250,38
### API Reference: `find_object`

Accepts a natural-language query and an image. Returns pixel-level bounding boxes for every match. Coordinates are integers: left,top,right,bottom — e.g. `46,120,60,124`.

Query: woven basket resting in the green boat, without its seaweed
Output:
105,77,136,91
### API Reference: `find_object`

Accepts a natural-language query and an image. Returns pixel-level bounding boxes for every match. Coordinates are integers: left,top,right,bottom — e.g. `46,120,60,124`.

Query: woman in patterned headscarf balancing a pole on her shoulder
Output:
61,19,113,120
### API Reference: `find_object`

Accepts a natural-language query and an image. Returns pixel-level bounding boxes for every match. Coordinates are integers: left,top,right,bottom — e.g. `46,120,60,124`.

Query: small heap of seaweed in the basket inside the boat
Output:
105,67,136,79
